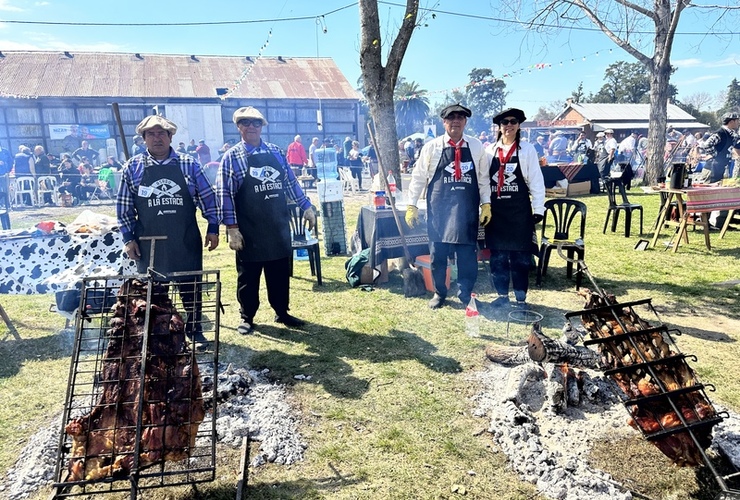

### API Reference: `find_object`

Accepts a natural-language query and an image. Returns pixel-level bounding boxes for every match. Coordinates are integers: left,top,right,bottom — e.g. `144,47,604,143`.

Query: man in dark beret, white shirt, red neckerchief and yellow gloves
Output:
406,103,491,309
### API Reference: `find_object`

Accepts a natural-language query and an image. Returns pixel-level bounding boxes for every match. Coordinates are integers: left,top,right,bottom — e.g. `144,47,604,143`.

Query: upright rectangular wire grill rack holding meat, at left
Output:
51,271,221,499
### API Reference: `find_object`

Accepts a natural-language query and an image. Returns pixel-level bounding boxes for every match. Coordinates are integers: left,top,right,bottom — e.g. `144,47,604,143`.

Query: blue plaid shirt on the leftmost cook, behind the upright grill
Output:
116,148,218,242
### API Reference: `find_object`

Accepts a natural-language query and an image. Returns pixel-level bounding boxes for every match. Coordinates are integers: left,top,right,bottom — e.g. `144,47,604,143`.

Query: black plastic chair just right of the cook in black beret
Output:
537,198,586,288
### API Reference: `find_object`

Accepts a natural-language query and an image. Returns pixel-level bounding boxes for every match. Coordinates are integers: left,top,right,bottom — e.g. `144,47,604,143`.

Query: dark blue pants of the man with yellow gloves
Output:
429,241,478,302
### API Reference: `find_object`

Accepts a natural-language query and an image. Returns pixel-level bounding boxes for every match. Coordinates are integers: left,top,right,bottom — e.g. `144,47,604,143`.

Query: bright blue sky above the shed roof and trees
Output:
0,0,740,114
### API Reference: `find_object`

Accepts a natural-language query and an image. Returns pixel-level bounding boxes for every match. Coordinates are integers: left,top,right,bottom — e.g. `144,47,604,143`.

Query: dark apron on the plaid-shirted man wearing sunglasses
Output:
234,153,292,262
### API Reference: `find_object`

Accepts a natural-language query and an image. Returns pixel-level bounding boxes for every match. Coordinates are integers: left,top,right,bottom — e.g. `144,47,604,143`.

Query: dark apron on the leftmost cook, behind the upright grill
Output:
134,159,203,274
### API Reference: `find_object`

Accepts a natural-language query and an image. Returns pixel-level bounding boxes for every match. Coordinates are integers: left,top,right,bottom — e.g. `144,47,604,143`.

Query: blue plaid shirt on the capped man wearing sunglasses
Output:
216,141,311,226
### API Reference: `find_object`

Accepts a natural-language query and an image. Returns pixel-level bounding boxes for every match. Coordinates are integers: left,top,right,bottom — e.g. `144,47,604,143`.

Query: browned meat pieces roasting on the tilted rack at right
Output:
566,290,722,466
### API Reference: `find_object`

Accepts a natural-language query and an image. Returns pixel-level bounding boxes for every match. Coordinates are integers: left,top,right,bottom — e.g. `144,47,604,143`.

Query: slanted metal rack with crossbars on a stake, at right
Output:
558,241,740,500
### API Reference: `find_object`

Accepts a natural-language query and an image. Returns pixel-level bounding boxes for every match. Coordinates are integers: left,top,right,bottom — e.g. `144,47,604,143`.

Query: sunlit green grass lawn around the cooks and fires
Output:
0,189,740,499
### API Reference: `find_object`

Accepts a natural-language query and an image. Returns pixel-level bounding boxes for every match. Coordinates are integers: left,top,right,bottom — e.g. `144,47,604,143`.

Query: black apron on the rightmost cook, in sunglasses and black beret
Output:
486,145,537,253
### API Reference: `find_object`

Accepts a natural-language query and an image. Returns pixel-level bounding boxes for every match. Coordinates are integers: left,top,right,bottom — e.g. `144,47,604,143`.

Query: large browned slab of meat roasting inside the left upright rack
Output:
65,280,205,481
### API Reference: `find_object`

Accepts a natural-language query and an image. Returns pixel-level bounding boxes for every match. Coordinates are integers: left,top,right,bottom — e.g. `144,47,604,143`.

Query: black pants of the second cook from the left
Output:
236,252,291,323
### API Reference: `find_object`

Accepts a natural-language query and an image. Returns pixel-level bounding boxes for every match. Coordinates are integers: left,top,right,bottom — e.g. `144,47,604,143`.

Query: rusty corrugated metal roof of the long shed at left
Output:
0,51,360,100
